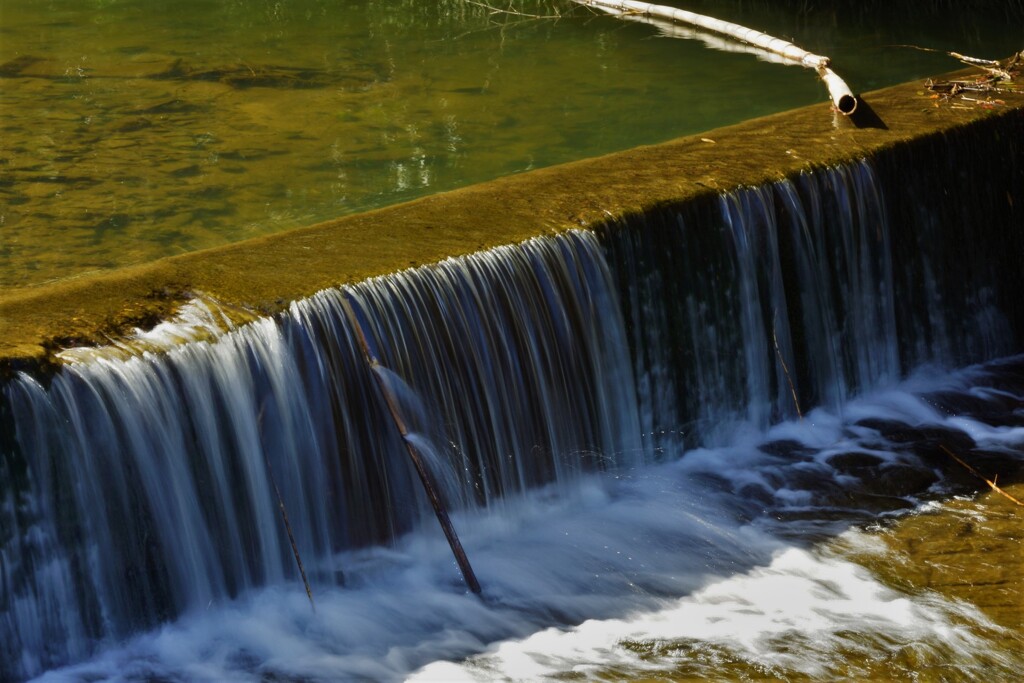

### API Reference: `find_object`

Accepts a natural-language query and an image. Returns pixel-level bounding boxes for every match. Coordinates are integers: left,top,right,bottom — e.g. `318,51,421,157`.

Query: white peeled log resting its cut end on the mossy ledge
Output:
573,0,857,116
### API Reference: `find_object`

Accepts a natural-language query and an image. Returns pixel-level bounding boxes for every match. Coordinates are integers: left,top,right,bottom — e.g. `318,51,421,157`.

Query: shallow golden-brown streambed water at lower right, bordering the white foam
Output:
598,483,1024,683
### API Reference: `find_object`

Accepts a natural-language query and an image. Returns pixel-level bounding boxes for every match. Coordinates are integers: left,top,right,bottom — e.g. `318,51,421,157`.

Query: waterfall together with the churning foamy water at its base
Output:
0,145,1024,680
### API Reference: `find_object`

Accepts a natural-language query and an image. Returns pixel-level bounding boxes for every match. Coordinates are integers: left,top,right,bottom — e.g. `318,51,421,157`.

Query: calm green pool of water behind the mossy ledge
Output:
0,0,1024,289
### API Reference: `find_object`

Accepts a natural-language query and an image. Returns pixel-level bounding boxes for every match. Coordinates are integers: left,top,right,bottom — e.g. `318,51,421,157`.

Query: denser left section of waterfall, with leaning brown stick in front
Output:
0,232,643,675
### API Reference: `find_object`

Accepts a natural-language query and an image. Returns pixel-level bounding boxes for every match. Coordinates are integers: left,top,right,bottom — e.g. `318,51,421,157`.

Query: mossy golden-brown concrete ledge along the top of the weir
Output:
0,72,1024,376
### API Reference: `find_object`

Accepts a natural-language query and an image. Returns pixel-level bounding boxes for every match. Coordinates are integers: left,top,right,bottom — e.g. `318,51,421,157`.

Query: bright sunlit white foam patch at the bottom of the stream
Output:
410,548,1007,681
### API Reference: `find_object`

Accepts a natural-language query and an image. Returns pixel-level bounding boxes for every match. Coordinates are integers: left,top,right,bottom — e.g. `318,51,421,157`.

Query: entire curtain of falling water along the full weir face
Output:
0,137,1017,678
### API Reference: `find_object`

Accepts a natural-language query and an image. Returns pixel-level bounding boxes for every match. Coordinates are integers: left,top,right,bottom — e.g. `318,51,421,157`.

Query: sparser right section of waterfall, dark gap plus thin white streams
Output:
608,163,901,445
